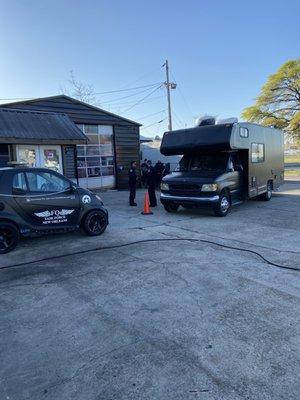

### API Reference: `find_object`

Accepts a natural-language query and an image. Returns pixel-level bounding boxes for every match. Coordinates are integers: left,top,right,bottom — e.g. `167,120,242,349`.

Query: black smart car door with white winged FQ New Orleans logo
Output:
13,170,80,229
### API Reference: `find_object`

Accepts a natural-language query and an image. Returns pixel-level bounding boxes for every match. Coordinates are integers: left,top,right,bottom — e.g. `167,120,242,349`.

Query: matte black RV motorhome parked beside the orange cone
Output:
160,120,284,217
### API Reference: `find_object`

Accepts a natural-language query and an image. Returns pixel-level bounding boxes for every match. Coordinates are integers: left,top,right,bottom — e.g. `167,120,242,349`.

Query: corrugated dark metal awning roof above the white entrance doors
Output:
0,108,87,144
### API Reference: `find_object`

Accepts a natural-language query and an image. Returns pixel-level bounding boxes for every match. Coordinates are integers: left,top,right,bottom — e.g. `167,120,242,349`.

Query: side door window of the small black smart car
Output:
26,172,70,192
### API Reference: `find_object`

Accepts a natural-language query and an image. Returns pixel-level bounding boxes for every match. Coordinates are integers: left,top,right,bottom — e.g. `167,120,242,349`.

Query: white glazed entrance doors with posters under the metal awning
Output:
17,145,63,173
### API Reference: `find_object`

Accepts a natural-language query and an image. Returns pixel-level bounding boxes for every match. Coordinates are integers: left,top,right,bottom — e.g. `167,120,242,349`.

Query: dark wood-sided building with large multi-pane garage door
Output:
0,95,140,189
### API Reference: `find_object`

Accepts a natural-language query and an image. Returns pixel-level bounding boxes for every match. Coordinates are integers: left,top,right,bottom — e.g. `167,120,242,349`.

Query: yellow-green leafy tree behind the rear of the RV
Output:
242,59,300,139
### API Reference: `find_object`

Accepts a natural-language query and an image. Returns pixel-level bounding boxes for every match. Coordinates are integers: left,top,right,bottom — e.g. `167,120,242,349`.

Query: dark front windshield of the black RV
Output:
176,153,228,171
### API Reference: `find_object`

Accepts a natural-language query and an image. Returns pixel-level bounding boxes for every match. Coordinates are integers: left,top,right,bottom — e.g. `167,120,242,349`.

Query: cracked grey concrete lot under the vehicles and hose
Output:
0,182,300,400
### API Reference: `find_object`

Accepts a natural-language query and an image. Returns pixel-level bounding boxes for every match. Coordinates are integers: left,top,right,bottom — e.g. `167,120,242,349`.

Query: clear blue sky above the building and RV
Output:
0,0,300,136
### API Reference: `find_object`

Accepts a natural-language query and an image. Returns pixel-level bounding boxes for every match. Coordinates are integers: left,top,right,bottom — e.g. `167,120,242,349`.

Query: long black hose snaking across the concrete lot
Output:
0,238,300,271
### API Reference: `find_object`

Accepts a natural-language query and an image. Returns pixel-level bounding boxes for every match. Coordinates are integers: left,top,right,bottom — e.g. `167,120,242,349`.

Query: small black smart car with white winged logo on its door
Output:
0,166,108,254
